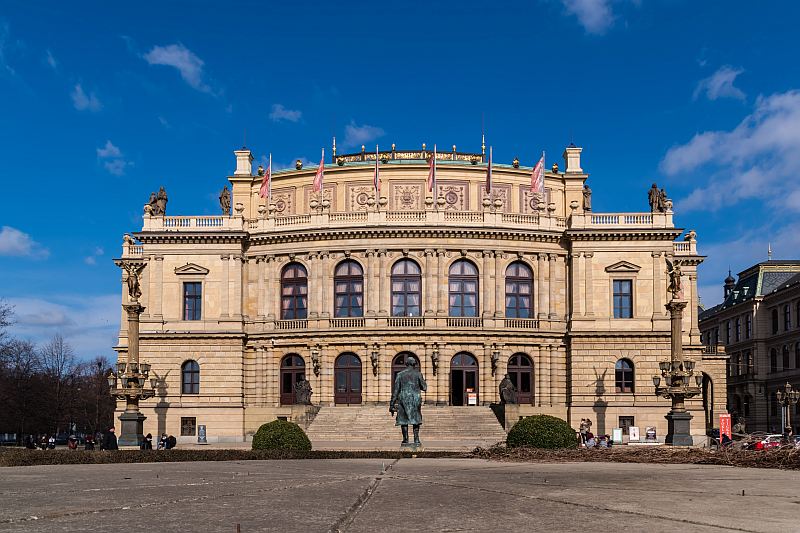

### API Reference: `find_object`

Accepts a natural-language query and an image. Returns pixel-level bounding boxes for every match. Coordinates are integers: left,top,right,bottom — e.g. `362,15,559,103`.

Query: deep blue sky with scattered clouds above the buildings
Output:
0,0,800,357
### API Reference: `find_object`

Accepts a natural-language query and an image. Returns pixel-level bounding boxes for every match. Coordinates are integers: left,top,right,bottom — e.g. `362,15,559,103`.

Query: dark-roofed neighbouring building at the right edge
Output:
700,260,800,433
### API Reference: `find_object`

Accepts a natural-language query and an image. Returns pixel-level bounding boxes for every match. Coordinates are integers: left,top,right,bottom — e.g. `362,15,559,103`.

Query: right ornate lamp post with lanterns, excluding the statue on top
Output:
653,296,703,446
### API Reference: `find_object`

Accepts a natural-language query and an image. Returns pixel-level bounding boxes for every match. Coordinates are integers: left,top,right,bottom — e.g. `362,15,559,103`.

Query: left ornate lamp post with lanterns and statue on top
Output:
108,263,156,447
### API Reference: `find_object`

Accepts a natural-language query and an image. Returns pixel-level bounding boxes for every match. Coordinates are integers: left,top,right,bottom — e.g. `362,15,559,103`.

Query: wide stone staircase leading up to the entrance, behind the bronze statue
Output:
306,405,506,449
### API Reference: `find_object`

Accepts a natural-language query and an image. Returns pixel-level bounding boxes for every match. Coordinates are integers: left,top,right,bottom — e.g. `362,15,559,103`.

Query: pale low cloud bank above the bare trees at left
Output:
8,294,120,359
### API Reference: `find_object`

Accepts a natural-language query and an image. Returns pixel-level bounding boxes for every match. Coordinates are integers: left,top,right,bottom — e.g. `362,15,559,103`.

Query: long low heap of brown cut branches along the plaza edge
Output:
472,446,800,470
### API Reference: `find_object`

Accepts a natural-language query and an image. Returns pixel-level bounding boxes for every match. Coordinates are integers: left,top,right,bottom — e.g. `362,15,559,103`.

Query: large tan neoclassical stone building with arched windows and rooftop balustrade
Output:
117,140,726,441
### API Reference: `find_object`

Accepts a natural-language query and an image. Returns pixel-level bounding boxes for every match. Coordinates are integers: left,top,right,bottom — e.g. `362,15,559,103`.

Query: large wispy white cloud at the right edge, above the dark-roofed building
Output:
661,90,800,212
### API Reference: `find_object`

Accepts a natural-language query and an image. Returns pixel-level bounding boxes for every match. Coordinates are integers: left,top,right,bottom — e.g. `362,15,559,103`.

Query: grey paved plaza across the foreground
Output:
0,459,800,533
